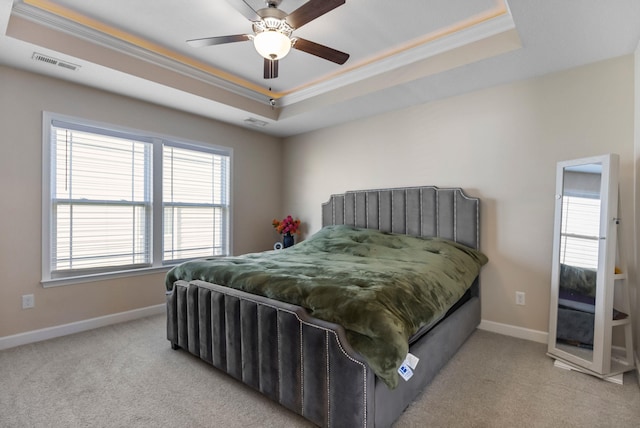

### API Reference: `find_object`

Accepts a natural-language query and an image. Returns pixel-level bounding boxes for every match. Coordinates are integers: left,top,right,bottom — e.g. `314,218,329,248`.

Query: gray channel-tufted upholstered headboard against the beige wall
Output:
322,186,480,249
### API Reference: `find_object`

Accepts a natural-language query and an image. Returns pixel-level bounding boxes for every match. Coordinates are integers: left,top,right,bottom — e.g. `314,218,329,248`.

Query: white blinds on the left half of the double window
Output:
50,121,152,277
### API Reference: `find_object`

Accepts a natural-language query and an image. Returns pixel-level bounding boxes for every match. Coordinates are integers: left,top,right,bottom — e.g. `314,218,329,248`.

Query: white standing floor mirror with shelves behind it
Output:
548,154,633,378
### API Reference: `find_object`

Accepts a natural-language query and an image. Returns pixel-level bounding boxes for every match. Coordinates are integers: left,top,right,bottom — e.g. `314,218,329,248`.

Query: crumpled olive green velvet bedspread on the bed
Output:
166,225,487,388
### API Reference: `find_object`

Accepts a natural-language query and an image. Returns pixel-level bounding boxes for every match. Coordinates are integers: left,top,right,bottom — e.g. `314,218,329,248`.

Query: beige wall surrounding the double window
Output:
0,66,283,337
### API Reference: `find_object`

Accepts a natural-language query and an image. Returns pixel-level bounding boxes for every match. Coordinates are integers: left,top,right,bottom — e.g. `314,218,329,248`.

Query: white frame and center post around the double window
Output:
40,111,233,287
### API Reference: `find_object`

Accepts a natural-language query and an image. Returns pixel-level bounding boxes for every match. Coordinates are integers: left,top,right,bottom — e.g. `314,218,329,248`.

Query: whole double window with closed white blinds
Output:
42,113,231,285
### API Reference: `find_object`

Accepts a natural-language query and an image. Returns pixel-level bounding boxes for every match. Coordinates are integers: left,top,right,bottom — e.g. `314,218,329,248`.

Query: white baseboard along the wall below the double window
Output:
0,304,166,351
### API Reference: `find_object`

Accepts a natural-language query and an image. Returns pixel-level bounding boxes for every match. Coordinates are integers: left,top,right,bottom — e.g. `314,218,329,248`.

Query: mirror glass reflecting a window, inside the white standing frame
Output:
556,163,602,361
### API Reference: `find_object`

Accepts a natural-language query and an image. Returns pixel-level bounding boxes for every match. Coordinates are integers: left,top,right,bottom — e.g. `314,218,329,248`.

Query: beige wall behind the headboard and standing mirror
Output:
284,55,634,332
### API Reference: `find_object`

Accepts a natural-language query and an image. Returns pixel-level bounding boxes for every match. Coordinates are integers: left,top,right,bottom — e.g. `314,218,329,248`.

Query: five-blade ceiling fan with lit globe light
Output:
187,0,349,79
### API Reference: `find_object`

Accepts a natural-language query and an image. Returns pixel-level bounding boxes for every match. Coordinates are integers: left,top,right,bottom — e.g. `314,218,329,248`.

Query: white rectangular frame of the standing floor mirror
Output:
547,154,619,375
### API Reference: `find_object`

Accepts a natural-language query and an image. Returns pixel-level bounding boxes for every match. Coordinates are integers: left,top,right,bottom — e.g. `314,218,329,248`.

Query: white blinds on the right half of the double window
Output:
163,145,229,262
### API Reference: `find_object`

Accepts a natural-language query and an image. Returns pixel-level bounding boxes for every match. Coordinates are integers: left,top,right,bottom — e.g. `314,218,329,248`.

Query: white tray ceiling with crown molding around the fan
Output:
0,0,640,136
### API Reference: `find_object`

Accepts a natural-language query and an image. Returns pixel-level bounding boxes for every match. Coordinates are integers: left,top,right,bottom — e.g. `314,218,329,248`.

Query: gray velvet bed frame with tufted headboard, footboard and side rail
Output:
167,186,480,427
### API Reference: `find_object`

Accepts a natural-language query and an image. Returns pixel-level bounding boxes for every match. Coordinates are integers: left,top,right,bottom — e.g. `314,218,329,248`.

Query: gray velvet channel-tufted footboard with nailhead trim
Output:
167,281,374,427
